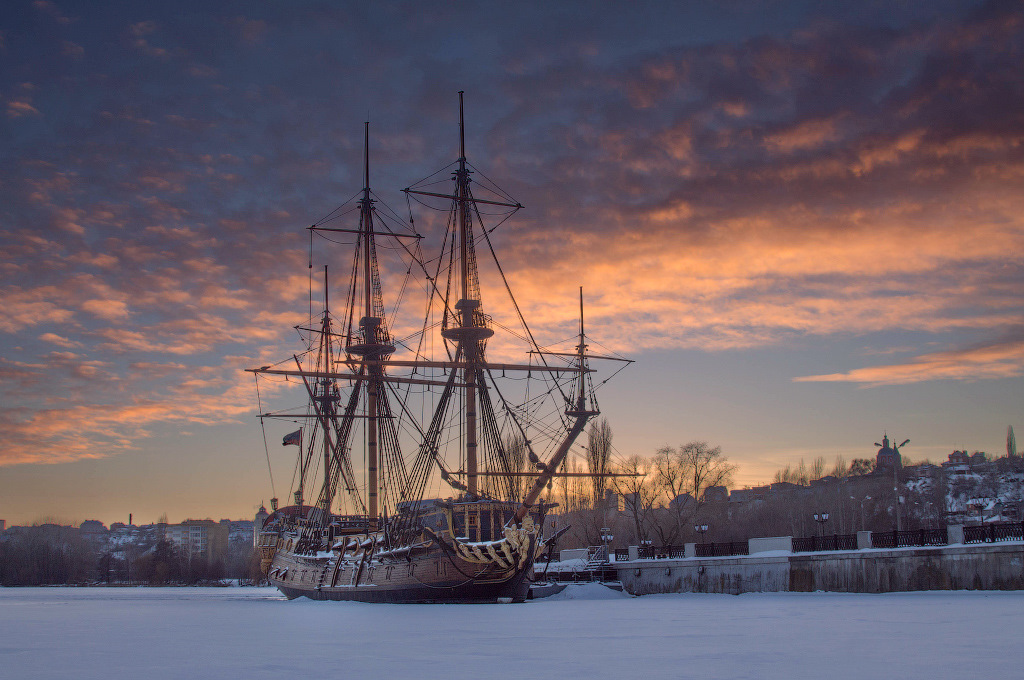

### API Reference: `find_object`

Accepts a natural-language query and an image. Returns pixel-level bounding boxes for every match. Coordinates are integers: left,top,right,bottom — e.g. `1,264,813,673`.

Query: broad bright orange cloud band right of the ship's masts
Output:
477,188,1024,358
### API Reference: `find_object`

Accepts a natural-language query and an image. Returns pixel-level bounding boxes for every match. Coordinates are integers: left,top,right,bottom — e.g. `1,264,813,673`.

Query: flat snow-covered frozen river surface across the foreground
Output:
0,585,1024,680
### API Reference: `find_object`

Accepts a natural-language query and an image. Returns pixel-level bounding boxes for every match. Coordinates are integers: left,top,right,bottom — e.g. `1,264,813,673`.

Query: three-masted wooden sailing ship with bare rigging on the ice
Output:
251,92,614,602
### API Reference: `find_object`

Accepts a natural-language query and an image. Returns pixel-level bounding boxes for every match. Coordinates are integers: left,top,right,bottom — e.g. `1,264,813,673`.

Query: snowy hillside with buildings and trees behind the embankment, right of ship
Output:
552,429,1024,548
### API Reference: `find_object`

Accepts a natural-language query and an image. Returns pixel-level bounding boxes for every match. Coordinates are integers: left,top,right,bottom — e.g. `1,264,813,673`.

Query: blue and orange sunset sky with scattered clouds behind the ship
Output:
0,0,1024,525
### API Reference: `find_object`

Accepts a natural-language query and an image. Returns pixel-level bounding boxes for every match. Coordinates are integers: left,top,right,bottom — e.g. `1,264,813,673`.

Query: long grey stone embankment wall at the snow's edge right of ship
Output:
615,542,1024,595
